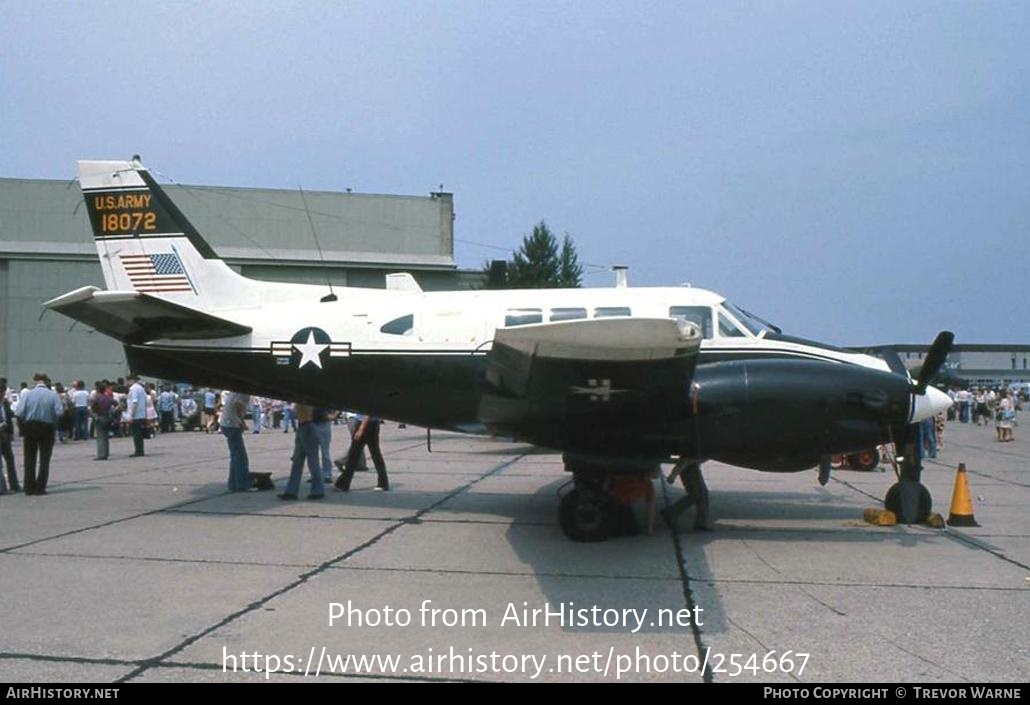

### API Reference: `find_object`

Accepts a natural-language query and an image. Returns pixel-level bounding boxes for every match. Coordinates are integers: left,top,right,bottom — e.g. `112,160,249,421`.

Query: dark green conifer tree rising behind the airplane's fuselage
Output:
484,221,583,289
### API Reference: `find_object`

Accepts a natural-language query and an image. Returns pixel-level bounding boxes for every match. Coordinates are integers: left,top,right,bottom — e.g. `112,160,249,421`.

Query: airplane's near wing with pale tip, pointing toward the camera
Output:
479,318,701,448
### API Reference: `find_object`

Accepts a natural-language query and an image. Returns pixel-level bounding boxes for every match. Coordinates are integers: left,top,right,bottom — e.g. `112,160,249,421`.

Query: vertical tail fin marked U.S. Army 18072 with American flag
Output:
78,159,250,310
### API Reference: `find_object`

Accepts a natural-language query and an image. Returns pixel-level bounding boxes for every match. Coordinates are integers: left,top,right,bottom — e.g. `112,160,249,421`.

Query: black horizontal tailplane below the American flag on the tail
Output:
43,287,251,343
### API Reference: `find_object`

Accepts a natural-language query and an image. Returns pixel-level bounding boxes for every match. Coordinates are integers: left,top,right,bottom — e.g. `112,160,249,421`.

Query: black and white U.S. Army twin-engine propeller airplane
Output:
45,158,953,540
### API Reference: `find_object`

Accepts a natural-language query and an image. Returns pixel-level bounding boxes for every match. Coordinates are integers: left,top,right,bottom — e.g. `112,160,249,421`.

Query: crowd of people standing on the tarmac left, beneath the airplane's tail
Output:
0,373,389,500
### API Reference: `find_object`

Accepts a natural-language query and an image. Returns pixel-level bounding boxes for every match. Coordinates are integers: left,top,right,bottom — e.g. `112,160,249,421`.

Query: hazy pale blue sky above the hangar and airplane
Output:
0,0,1030,344
